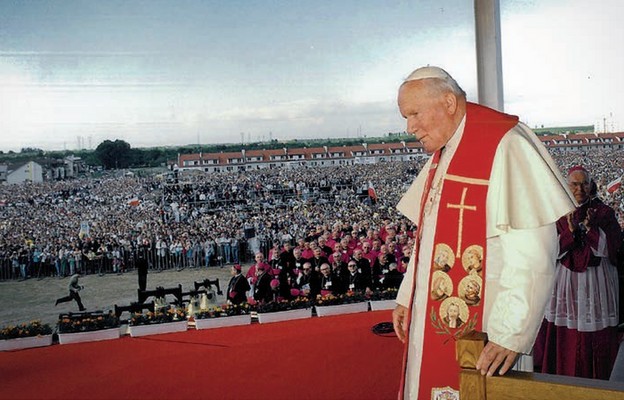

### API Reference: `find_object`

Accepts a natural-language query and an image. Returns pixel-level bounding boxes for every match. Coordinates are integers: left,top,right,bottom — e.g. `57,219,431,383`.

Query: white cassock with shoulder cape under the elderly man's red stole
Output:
396,116,576,399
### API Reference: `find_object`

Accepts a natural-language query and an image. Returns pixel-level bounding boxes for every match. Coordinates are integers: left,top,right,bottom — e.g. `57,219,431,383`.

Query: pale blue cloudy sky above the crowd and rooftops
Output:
0,0,624,152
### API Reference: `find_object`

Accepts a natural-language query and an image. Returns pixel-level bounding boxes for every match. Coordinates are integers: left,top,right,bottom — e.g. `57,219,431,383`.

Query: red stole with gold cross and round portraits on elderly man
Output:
400,103,518,399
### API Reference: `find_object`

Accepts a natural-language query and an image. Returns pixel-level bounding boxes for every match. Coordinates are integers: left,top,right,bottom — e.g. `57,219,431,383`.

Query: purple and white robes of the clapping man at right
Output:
534,198,621,379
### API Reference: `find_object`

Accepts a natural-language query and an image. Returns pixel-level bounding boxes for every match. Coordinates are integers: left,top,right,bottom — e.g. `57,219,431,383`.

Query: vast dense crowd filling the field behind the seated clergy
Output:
0,145,624,280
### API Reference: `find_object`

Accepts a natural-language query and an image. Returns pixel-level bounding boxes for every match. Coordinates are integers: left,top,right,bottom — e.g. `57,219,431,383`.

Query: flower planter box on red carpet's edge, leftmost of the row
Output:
0,320,52,351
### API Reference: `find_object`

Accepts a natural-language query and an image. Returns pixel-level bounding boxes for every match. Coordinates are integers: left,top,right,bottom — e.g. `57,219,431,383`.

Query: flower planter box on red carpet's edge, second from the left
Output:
58,311,119,344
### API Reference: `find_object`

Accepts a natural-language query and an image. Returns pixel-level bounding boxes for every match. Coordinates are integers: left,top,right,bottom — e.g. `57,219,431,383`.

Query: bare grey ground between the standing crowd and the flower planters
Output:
0,267,234,327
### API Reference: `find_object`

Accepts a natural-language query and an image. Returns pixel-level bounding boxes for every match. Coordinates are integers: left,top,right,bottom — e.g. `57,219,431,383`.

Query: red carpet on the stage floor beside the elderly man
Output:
0,311,402,400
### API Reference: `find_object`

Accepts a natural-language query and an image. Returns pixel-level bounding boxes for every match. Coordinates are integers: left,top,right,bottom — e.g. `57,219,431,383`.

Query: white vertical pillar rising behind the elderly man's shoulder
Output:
474,0,505,111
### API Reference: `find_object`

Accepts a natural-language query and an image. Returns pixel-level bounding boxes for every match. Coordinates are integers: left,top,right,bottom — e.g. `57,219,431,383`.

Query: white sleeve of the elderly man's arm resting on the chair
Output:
484,223,559,353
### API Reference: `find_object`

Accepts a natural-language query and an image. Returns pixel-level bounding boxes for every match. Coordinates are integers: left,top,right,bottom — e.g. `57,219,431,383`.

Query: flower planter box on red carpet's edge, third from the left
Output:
128,307,188,337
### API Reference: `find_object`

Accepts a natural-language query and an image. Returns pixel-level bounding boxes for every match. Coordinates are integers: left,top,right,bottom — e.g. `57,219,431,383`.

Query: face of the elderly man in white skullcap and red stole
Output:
398,79,457,153
